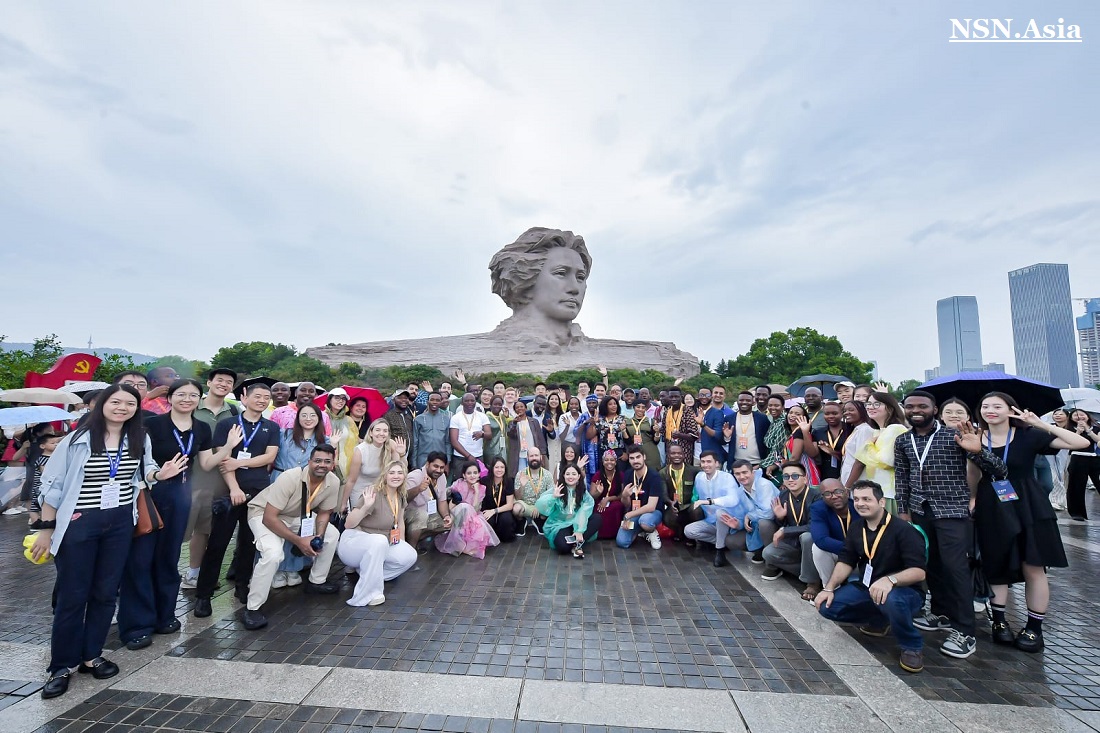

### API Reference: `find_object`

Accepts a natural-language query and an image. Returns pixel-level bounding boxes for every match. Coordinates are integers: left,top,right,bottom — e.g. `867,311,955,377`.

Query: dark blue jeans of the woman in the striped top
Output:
48,504,134,674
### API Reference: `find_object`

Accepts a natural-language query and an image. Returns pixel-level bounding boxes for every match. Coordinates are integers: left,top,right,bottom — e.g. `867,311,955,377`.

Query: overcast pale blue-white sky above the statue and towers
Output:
0,0,1100,381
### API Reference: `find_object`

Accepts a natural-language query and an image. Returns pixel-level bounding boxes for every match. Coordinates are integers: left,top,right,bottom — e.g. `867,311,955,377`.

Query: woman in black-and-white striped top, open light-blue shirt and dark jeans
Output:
31,384,187,699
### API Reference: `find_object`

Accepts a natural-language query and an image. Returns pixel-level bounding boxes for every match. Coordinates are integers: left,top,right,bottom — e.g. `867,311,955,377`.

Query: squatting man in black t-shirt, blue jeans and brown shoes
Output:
814,481,926,672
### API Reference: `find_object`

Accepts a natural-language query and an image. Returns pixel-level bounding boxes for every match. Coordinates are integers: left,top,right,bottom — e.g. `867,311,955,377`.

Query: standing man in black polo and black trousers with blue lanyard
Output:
195,383,279,619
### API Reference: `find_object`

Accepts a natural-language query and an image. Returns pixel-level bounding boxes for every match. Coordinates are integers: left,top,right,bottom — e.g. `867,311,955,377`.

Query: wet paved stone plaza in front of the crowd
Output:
0,496,1100,733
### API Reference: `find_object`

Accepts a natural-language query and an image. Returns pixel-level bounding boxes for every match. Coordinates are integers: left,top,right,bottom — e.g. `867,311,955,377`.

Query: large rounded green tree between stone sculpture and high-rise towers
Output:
728,328,872,384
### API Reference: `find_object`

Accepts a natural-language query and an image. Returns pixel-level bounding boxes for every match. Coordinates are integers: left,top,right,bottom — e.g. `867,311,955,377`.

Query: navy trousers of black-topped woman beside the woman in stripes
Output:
119,478,191,642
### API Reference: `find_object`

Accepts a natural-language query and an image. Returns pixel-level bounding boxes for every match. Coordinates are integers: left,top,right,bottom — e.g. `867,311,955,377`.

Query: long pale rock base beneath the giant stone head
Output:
306,329,699,379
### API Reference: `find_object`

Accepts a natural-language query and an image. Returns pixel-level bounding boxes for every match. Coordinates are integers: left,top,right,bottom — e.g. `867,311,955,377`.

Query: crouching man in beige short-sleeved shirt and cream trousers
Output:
244,444,340,631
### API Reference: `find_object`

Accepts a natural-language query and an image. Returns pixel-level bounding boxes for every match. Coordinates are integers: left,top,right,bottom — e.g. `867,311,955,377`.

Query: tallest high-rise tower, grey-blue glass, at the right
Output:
1009,263,1078,387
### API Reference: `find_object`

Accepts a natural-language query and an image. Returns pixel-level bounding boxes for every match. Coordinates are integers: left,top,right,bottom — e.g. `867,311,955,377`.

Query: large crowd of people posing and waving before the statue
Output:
6,368,1100,698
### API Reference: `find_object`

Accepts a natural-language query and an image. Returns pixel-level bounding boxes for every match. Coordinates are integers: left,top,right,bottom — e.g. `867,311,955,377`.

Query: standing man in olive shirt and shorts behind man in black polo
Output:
179,367,240,588
